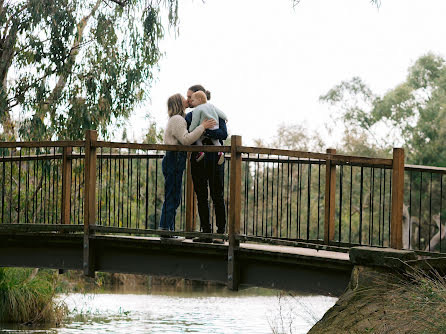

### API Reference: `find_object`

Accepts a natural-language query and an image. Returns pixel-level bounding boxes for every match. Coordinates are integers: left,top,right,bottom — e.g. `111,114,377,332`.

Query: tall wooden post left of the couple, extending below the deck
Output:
83,130,98,277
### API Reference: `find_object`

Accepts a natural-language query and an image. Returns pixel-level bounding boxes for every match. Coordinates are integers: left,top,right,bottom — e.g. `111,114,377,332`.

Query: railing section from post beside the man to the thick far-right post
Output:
235,147,401,246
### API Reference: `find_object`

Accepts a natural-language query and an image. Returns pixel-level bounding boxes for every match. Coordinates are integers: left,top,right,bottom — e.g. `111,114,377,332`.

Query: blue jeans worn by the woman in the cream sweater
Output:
159,151,186,231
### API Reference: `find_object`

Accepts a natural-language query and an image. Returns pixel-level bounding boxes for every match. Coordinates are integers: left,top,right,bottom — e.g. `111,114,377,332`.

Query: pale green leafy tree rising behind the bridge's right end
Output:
320,53,446,166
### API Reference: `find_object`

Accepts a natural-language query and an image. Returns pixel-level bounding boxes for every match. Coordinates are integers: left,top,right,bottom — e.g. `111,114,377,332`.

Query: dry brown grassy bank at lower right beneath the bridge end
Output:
309,269,446,334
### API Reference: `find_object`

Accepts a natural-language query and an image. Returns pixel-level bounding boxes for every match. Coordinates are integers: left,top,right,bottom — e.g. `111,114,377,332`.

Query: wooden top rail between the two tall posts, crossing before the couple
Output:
95,141,231,152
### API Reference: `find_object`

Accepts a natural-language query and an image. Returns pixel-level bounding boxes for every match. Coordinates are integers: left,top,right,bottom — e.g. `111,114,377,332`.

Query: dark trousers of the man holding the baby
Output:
191,152,226,233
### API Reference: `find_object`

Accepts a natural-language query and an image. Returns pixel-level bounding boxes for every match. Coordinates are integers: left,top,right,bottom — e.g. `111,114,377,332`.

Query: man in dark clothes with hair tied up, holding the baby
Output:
186,85,228,244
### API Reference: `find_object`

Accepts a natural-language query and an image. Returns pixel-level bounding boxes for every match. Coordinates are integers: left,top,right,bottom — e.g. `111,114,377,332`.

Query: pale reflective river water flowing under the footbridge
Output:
0,289,336,334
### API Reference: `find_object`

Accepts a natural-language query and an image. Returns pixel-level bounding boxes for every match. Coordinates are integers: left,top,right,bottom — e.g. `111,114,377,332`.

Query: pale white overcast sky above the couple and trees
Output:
123,0,446,146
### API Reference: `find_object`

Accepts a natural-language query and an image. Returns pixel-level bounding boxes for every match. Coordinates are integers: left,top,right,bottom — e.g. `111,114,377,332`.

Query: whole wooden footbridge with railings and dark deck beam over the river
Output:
0,131,446,294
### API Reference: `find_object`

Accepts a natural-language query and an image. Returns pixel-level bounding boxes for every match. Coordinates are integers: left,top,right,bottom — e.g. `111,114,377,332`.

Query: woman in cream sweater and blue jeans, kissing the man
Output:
159,94,216,235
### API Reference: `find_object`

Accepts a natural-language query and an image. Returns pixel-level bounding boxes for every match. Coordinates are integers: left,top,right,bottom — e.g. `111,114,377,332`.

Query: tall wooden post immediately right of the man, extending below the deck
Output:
228,136,242,290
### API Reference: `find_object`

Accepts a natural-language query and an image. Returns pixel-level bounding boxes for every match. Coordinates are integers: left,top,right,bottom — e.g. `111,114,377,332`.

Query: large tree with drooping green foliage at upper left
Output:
0,0,178,140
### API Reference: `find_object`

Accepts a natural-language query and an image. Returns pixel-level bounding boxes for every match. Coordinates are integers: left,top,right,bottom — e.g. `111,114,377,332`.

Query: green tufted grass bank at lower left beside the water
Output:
0,268,67,325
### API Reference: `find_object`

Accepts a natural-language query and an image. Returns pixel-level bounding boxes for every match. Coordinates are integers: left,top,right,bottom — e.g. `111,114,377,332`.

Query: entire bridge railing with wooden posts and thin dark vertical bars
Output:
0,132,446,252
